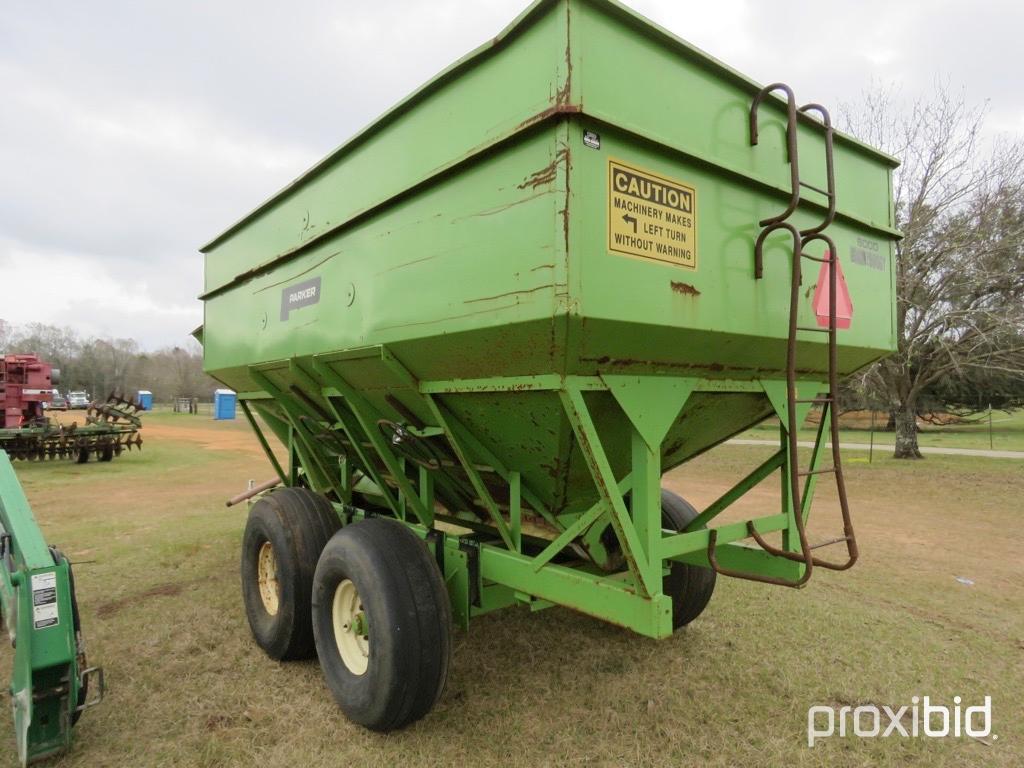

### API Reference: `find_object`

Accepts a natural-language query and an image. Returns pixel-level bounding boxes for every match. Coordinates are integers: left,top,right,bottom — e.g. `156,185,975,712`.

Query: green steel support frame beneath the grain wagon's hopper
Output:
240,346,827,638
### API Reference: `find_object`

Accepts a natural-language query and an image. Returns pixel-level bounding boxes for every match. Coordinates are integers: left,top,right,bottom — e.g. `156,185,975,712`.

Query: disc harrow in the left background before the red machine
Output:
0,392,142,464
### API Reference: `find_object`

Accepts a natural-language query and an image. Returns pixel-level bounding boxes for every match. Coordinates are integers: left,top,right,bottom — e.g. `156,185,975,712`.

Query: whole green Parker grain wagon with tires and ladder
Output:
199,0,898,730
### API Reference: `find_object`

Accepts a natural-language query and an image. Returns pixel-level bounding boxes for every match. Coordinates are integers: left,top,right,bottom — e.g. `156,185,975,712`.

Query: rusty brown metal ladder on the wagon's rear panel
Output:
708,83,858,587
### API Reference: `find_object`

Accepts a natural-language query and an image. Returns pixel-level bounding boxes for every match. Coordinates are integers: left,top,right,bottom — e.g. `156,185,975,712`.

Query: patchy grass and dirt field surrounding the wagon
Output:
0,414,1024,768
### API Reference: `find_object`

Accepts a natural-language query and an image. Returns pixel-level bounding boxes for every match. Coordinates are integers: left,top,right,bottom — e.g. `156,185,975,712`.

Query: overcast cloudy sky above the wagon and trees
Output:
0,0,1024,348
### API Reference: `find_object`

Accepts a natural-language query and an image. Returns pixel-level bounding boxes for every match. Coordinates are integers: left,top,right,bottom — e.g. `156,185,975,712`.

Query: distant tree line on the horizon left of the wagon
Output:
0,319,220,402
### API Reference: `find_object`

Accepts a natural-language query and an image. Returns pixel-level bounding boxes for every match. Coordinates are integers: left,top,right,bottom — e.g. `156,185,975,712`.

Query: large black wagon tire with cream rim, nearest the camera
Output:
312,517,452,731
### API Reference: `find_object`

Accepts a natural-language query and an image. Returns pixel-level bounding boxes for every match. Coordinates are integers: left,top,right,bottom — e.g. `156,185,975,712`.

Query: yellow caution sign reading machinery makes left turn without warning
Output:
608,159,697,269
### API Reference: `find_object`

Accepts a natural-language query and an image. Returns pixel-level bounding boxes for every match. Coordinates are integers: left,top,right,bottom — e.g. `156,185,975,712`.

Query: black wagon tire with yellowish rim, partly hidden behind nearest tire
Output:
242,488,341,660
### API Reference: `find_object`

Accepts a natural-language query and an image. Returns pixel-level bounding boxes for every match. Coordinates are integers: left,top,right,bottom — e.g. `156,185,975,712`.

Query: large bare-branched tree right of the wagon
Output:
845,86,1024,459
